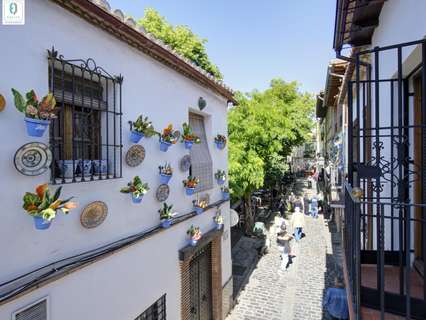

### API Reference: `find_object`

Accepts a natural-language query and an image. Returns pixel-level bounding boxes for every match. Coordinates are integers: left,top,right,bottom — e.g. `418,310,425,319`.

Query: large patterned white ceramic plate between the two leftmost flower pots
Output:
14,142,52,176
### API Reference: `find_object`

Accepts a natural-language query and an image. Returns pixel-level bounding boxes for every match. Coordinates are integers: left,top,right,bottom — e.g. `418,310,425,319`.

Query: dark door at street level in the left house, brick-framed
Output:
189,244,213,320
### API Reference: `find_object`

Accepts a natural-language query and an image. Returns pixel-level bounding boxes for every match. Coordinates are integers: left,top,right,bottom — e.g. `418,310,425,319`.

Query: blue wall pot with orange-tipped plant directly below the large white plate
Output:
22,184,77,230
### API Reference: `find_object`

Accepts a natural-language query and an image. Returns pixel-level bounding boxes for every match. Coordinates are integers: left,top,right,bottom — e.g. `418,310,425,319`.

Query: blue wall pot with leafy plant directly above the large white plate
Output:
12,88,56,137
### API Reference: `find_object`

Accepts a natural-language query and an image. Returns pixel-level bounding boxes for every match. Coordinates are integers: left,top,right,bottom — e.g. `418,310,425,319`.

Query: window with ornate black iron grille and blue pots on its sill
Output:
48,48,123,184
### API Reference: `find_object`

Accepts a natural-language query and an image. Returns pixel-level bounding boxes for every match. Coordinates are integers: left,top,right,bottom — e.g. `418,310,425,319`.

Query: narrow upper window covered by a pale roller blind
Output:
189,113,213,192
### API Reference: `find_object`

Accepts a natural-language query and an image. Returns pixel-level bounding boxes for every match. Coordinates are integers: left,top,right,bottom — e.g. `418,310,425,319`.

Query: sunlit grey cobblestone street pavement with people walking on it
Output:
226,180,341,320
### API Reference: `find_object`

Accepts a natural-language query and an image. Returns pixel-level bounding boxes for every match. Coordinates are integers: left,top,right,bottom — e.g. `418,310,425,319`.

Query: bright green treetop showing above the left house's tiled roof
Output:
137,8,222,79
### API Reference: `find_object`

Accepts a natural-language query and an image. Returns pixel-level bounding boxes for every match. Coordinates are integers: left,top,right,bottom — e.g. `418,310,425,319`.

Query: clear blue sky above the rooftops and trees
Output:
109,0,336,93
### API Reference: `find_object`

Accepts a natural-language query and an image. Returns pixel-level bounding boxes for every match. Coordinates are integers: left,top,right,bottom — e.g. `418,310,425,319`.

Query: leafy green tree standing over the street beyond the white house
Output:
228,79,314,232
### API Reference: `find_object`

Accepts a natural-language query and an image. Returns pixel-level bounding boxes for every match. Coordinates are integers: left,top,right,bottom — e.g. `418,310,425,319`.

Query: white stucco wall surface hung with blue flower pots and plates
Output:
0,0,231,320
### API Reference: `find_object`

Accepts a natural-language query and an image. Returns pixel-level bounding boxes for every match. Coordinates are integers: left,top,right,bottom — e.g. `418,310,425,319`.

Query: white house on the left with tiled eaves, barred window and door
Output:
0,0,233,320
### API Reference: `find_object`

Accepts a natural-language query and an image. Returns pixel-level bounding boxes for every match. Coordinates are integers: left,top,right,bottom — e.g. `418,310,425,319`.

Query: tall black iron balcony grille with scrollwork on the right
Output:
345,39,426,319
